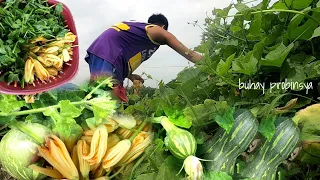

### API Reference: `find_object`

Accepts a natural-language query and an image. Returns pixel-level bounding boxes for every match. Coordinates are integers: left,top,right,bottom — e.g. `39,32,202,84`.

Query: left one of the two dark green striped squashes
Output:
198,109,259,175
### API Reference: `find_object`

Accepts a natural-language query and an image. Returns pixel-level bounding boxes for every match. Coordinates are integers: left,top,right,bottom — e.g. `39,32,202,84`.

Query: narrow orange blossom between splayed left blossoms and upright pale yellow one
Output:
77,140,90,177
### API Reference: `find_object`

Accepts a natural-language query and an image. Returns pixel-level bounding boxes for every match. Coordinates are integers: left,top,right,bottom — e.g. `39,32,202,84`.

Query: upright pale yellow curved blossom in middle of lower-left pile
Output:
83,125,108,165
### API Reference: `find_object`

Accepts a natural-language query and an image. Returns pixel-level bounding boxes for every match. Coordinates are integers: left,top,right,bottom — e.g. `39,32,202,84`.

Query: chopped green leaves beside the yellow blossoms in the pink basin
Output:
0,0,68,87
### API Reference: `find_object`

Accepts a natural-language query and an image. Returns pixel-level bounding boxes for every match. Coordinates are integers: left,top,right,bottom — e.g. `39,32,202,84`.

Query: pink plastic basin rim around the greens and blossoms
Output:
0,0,79,95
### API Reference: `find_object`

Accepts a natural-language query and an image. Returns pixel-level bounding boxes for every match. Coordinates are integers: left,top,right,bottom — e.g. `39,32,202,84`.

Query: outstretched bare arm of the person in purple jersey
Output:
148,26,202,63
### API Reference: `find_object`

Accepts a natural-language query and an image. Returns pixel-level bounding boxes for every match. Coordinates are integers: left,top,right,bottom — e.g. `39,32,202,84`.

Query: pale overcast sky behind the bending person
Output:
60,0,235,87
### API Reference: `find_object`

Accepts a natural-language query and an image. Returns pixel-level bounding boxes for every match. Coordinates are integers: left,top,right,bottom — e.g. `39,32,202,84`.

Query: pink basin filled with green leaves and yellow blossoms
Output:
0,0,79,95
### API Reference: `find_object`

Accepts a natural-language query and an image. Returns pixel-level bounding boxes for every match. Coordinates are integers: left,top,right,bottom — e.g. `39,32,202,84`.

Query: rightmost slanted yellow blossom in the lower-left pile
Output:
118,132,153,165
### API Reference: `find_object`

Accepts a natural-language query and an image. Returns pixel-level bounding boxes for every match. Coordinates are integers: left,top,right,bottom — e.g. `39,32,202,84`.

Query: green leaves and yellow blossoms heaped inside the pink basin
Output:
0,0,76,88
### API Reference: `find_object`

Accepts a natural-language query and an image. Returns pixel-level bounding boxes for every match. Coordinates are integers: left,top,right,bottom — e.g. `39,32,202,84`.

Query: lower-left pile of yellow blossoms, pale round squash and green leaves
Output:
0,79,153,180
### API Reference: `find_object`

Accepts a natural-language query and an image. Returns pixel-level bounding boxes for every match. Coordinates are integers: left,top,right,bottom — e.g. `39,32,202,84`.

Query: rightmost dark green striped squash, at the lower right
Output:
239,118,299,180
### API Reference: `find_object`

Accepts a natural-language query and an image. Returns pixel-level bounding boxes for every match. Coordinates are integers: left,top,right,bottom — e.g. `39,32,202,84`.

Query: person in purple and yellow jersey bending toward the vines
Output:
85,14,202,102
